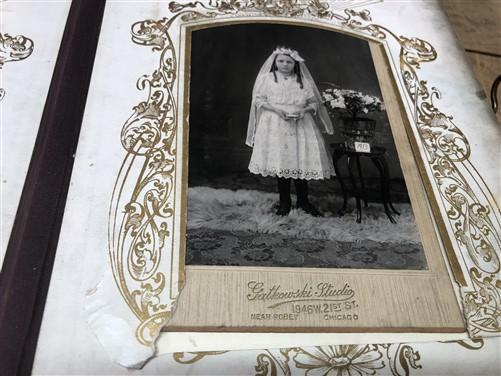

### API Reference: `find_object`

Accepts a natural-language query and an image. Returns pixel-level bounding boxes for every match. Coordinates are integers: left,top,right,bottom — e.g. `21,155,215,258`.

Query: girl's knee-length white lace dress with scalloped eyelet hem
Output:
249,72,335,180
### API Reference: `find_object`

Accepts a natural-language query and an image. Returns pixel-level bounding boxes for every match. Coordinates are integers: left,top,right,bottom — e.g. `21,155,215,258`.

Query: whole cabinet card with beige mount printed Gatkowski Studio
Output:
149,19,472,333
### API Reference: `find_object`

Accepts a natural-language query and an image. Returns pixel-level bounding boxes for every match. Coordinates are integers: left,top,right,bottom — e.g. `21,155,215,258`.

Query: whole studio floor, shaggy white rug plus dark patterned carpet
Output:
186,187,426,270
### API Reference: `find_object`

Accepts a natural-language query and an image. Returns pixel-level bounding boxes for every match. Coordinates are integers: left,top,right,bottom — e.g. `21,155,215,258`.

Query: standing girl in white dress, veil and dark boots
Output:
246,47,335,216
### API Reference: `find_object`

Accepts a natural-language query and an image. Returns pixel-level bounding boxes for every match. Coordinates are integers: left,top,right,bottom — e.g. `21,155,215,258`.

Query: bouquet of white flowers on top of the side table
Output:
322,87,385,118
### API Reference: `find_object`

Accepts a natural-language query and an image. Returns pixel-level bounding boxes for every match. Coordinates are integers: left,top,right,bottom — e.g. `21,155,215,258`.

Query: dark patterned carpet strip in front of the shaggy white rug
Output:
186,229,426,270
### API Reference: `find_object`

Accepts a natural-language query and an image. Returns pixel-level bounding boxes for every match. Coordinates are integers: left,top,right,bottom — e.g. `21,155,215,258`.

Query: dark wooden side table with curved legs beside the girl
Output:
331,143,400,223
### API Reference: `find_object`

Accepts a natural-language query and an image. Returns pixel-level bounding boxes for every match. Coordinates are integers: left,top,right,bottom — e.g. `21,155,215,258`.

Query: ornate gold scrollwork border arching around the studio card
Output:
109,0,501,344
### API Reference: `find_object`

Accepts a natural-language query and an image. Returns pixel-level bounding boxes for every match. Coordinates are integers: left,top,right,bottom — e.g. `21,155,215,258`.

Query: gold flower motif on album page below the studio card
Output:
293,345,384,376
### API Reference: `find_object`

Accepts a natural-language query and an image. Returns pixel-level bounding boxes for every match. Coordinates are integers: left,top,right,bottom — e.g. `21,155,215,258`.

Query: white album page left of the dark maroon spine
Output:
0,1,70,267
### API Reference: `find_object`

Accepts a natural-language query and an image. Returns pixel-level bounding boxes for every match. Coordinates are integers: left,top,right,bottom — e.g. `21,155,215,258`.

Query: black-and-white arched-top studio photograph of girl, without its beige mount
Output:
186,23,427,270
